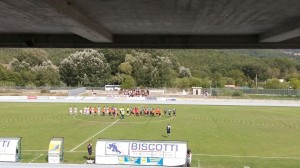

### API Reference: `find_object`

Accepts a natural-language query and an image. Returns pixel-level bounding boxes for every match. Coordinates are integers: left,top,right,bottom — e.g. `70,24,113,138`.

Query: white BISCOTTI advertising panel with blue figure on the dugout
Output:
95,139,187,166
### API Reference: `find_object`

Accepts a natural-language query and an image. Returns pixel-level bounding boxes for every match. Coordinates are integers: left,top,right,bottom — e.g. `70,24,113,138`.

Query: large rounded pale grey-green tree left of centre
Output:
59,49,111,87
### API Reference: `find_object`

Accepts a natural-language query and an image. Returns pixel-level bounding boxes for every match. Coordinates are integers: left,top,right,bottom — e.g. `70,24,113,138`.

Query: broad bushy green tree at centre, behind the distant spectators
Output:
119,50,178,88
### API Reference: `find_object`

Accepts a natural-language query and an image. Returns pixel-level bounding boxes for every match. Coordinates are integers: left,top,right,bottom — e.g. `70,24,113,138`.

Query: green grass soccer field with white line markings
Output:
0,103,300,168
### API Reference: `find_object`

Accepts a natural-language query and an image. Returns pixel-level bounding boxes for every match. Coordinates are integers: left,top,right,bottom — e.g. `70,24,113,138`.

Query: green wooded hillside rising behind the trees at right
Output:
171,50,300,78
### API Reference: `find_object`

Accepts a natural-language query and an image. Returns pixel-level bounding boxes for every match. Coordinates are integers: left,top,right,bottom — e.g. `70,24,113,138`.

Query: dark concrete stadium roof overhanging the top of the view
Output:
0,0,300,48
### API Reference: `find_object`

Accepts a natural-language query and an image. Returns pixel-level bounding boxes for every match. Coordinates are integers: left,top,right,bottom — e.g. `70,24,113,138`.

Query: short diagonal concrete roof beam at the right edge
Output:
259,18,300,43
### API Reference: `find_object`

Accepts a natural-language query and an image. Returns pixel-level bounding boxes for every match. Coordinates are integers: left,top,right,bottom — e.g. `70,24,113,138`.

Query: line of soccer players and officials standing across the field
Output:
69,106,176,117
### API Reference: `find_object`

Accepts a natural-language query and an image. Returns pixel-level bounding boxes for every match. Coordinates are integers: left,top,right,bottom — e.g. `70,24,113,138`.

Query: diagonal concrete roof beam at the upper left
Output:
44,0,113,43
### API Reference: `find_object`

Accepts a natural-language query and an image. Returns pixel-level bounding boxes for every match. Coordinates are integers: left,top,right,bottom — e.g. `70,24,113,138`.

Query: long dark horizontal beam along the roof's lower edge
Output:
0,34,300,49
